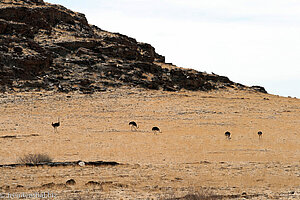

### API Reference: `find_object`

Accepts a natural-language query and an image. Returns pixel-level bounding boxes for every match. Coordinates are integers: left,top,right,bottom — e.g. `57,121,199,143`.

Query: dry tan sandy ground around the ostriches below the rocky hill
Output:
0,89,300,199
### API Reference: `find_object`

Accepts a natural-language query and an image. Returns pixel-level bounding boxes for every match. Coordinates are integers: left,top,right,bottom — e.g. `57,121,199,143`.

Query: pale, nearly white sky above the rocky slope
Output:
45,0,300,98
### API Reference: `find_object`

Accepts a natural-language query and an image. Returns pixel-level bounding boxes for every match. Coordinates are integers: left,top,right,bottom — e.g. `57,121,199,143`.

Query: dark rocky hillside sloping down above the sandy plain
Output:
0,0,266,93
